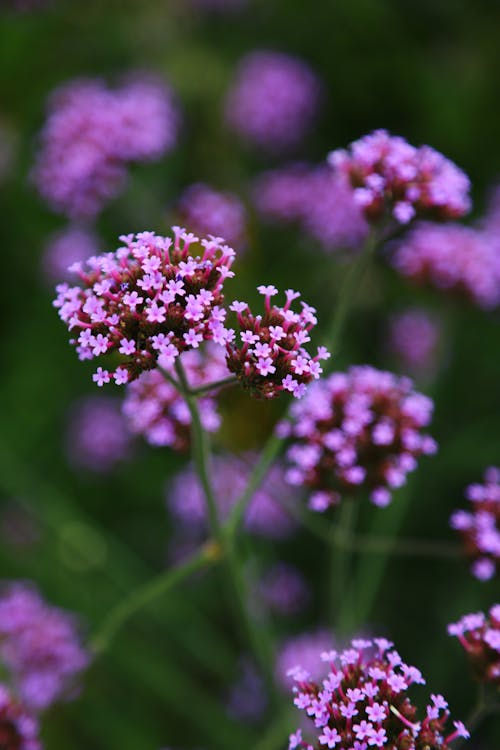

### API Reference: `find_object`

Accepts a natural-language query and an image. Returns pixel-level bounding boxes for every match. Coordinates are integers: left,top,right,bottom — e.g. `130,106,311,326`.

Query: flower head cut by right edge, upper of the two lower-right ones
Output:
450,466,500,581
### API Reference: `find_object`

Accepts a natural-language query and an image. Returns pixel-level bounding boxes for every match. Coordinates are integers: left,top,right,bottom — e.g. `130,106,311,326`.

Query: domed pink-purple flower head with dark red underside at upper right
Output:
328,130,470,224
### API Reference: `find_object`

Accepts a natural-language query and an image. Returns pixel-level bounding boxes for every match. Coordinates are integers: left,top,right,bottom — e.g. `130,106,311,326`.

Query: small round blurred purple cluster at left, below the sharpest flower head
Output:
65,396,131,472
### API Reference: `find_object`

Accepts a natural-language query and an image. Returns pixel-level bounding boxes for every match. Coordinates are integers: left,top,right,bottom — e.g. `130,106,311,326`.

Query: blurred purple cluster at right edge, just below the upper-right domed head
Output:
392,222,500,310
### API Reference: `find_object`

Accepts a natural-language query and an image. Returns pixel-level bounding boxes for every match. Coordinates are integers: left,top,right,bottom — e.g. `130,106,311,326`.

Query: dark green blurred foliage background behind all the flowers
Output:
0,0,500,750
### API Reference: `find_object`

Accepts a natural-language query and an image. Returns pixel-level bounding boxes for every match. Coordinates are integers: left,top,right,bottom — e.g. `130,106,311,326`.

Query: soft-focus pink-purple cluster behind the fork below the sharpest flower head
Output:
123,342,228,451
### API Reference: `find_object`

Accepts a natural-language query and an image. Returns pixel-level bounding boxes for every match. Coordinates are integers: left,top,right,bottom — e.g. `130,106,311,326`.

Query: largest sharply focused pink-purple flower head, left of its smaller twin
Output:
54,227,234,386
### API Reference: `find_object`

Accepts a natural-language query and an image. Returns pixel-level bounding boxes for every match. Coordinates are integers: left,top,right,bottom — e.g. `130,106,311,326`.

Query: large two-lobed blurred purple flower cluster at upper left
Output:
33,78,179,217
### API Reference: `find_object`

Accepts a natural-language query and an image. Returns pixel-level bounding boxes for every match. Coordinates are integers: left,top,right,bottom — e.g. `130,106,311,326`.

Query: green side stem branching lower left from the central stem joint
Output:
90,542,222,654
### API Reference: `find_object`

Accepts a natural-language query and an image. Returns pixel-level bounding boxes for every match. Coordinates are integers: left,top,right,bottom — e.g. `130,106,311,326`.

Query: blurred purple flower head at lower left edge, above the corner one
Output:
0,583,89,712
